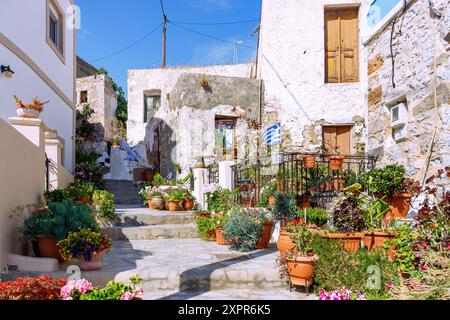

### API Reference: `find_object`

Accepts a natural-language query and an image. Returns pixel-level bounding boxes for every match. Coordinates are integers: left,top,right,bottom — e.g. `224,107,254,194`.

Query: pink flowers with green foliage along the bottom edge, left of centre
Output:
61,275,144,301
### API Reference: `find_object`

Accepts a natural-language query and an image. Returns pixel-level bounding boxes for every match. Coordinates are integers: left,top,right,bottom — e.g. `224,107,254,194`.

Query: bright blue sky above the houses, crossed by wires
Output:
75,0,261,91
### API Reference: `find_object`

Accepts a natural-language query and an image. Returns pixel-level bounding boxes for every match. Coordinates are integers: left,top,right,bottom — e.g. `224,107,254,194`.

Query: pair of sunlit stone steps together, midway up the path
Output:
103,205,197,241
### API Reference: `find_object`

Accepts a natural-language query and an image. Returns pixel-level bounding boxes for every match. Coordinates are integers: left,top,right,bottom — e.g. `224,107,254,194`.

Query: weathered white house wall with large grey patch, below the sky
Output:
125,65,262,177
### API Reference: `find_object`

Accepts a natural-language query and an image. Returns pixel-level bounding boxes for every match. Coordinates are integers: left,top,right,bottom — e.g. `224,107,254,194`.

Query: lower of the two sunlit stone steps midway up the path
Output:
102,223,198,241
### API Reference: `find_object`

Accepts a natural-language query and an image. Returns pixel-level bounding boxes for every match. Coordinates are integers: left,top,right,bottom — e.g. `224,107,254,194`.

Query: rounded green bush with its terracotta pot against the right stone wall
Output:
361,165,416,219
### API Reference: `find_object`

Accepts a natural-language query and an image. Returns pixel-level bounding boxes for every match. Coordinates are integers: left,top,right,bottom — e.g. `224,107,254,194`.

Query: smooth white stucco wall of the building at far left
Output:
0,0,75,172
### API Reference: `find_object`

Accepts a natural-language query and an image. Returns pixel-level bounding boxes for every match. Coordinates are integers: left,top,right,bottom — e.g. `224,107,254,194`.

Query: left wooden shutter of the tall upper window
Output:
325,10,341,83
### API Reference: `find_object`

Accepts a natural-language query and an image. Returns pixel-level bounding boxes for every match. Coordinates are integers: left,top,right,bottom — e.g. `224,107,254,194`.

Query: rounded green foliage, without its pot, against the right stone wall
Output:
361,165,405,197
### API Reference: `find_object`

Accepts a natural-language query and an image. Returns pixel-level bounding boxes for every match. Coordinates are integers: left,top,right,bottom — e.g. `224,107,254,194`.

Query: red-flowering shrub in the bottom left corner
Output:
0,275,66,300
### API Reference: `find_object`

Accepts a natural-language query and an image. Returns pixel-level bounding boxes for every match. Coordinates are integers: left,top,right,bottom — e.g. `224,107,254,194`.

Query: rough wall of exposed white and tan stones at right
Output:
366,0,450,179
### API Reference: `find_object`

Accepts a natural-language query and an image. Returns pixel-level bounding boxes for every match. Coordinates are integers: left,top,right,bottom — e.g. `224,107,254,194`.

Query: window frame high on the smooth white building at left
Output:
45,0,66,64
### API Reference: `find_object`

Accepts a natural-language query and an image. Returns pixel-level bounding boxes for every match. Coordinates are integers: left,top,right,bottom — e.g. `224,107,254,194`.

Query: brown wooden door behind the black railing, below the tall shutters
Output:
322,126,352,155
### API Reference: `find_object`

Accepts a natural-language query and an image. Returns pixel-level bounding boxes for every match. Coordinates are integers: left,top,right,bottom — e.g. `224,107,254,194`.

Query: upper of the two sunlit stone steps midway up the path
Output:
116,208,194,227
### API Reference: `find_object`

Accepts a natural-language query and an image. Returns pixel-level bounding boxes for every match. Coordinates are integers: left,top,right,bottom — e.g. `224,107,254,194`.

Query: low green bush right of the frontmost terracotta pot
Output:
312,237,397,298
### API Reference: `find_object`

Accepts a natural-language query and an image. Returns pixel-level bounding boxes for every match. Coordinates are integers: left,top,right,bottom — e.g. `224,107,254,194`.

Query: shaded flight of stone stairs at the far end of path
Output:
106,180,143,206
